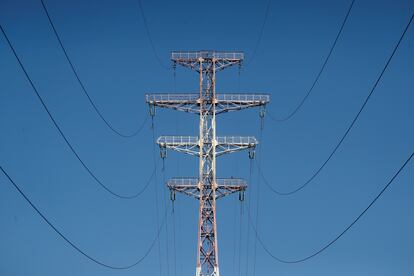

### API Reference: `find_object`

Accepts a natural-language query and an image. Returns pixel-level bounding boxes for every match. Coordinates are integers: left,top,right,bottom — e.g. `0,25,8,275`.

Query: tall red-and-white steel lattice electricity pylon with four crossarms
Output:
146,51,269,276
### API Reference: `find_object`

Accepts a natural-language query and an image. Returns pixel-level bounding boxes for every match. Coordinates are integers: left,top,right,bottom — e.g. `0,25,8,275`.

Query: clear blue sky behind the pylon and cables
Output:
0,0,414,276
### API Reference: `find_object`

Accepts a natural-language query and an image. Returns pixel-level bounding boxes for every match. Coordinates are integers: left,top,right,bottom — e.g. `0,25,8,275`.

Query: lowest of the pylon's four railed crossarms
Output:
167,177,247,199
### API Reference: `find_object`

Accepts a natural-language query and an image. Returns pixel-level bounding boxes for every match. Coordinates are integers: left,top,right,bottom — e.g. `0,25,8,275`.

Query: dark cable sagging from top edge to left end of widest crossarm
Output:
40,0,148,138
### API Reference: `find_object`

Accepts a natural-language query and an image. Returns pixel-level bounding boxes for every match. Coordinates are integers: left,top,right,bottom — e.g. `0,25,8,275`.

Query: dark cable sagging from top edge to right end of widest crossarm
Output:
268,0,355,122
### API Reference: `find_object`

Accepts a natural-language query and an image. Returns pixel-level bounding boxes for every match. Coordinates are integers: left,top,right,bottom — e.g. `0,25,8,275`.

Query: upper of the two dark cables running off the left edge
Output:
0,24,156,199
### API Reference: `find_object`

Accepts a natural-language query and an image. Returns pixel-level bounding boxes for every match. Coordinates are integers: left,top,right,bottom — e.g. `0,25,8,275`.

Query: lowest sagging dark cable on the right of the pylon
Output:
248,152,414,264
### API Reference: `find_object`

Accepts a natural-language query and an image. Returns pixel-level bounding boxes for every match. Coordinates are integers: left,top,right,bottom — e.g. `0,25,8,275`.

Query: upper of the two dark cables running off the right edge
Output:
258,11,414,196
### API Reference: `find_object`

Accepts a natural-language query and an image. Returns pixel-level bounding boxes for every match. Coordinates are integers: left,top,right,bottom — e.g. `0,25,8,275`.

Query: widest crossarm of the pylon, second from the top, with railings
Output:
145,93,270,114
